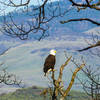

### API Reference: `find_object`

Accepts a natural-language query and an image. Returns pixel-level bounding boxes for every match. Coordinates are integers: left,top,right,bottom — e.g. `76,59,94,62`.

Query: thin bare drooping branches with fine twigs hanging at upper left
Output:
0,0,69,40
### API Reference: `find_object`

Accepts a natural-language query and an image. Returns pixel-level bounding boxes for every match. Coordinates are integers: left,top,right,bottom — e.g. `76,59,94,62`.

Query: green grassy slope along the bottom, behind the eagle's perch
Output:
0,87,88,100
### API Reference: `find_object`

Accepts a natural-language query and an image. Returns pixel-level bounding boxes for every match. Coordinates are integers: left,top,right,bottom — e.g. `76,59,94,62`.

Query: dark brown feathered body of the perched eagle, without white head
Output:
43,54,56,76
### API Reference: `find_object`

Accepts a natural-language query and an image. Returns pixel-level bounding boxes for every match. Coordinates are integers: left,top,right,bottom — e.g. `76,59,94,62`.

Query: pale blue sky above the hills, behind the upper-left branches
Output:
0,0,60,15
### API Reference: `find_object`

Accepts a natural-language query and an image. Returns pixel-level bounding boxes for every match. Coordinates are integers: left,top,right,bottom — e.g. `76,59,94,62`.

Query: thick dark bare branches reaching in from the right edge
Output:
60,0,100,52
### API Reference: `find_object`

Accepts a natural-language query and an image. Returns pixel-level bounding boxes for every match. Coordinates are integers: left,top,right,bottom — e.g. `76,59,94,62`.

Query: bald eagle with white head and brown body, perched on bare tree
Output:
43,50,56,76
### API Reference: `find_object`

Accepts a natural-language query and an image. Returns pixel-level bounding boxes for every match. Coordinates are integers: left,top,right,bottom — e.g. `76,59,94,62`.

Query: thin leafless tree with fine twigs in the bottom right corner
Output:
80,67,100,100
